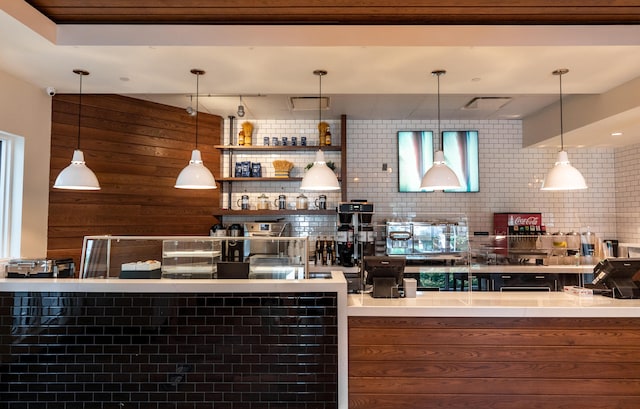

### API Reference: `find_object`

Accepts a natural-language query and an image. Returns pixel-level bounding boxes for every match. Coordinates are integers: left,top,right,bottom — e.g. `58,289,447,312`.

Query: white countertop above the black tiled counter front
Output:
0,271,347,293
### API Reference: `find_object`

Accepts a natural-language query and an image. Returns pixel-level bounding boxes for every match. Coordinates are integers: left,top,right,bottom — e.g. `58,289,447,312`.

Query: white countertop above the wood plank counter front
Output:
347,291,640,318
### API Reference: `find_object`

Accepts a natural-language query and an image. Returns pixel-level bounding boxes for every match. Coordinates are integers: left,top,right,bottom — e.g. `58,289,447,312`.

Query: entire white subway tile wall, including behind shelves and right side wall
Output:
216,116,640,242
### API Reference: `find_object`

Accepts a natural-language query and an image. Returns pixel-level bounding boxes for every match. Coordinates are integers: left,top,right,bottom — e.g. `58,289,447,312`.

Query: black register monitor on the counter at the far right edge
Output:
592,258,640,298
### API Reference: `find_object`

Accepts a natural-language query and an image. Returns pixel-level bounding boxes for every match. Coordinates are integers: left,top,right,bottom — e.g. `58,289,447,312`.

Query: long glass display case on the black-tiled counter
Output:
80,236,309,279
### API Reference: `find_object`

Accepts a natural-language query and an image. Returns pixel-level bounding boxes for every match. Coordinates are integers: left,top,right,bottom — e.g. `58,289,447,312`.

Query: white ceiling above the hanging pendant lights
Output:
0,0,640,146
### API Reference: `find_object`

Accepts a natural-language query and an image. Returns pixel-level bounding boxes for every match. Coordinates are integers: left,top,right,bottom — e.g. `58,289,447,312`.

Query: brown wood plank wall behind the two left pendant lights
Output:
47,94,223,267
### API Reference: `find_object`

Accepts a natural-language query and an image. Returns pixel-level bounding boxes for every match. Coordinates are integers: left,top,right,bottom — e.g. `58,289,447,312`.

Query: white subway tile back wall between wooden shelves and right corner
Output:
347,120,616,238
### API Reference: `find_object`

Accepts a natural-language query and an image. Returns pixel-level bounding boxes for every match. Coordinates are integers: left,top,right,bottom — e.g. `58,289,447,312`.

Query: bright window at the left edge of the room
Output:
0,132,24,259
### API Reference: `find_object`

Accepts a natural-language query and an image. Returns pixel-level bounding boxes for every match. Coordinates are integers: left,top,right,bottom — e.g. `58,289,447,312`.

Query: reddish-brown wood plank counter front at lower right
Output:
349,317,640,409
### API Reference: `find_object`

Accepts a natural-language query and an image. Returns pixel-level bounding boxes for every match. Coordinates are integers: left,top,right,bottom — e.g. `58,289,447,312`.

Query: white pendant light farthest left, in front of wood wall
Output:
53,70,100,190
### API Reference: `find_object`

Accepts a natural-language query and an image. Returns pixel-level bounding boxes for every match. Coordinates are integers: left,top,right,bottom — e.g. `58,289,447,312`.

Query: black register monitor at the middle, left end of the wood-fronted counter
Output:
362,256,406,298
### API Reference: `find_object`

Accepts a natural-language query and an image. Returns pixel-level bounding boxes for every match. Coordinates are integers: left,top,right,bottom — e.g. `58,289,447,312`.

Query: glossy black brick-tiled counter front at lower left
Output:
0,276,345,409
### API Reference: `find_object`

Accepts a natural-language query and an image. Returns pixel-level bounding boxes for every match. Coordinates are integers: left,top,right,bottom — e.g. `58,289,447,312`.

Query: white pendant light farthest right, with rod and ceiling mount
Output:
540,68,587,190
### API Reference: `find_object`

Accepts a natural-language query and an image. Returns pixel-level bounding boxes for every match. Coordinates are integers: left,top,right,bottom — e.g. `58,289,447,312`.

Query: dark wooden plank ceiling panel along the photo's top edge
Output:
27,0,640,25
